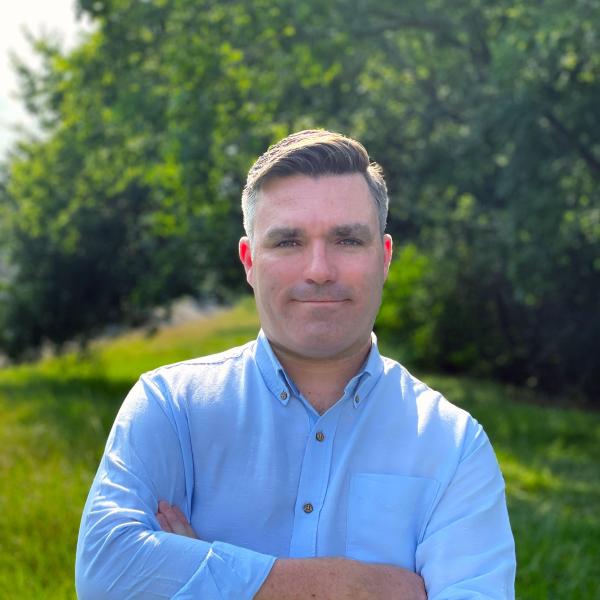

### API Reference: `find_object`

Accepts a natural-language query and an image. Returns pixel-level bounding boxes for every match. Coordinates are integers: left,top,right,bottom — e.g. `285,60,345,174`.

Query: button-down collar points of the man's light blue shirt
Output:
256,329,383,408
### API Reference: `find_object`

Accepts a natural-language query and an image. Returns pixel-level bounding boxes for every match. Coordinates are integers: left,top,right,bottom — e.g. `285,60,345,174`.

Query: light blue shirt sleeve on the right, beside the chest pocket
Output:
416,421,516,600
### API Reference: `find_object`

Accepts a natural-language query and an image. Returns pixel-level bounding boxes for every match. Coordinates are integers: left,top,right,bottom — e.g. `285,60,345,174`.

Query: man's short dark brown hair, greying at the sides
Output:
242,129,389,240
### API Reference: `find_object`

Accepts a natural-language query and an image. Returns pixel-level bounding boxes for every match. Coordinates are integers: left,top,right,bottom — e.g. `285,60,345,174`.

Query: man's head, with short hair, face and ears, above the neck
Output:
239,131,392,360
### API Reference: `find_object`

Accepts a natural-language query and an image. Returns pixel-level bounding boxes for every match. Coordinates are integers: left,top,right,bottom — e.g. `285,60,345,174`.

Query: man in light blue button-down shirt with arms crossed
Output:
76,131,515,600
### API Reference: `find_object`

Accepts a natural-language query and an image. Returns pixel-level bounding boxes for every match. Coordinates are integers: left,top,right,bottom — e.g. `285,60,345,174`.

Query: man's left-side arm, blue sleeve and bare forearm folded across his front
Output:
75,379,425,600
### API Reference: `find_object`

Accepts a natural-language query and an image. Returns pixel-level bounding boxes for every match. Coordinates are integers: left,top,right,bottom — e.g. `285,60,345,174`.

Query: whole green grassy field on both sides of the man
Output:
0,303,600,600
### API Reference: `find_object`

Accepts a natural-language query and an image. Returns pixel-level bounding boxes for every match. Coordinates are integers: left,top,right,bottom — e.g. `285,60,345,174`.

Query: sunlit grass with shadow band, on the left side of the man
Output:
0,302,258,600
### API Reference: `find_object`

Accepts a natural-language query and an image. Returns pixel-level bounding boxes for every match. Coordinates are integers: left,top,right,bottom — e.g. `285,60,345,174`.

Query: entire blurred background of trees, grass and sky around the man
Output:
0,0,600,598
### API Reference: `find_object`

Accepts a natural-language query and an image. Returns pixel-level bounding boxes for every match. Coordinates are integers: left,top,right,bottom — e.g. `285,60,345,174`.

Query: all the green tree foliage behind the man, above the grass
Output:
0,0,600,399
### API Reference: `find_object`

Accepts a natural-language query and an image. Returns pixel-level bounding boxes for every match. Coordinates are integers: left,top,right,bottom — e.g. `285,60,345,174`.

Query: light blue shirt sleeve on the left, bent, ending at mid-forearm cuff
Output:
75,378,275,600
